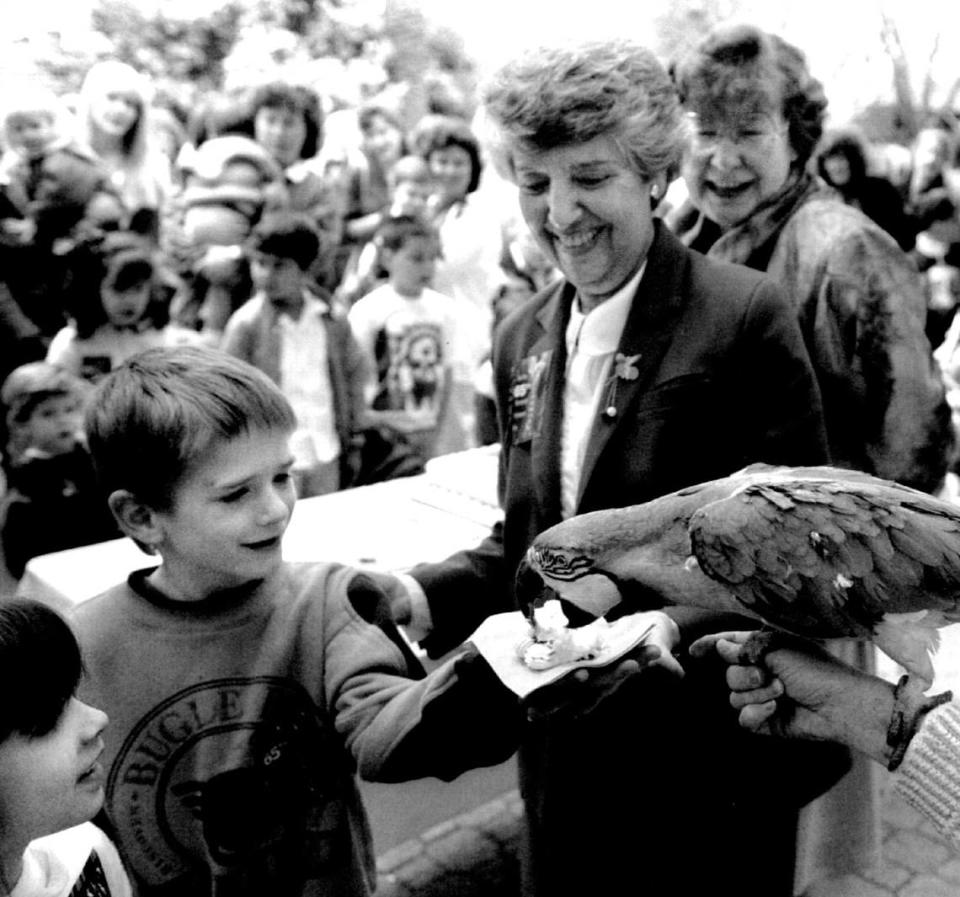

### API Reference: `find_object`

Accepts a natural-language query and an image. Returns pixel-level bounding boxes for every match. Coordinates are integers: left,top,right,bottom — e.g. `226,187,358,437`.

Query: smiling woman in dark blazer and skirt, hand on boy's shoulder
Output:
385,41,846,897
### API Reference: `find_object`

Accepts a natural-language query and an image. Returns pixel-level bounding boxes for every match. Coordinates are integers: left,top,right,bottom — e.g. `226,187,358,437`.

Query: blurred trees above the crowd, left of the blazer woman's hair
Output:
14,0,475,134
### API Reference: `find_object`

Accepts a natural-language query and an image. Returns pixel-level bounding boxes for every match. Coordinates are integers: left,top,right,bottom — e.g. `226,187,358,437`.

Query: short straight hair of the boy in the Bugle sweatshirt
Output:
84,346,296,510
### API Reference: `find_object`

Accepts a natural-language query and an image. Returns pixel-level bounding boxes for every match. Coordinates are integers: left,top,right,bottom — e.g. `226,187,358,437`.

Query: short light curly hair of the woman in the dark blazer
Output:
483,40,687,188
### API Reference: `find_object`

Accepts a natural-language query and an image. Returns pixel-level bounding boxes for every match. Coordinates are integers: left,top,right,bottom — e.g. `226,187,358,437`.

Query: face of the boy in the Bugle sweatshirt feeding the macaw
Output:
151,430,297,600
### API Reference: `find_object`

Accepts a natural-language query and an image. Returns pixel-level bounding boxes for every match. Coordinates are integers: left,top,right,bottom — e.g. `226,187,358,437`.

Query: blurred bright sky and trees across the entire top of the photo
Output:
7,0,960,150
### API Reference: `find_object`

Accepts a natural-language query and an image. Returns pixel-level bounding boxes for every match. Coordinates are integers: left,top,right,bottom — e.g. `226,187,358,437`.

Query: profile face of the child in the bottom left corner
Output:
0,698,107,838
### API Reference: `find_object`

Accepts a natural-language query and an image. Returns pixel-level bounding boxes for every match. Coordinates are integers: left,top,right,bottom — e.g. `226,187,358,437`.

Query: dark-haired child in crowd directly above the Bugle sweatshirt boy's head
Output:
47,232,198,382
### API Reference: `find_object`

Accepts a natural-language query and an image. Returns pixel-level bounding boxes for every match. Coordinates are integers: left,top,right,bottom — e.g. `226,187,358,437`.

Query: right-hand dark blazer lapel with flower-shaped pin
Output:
577,222,687,511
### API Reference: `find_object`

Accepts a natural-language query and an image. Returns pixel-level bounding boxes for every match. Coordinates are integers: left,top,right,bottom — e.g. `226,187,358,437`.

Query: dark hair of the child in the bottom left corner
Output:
0,598,83,742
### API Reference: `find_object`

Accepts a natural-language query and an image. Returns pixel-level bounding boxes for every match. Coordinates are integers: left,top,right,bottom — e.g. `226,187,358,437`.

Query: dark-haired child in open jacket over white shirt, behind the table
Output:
221,212,366,498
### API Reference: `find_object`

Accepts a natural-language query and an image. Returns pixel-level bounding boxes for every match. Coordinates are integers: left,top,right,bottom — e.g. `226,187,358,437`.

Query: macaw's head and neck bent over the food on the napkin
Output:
516,480,729,626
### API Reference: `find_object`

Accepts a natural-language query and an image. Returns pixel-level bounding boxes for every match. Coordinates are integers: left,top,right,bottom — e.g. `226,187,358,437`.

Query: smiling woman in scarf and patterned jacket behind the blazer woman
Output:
674,25,953,491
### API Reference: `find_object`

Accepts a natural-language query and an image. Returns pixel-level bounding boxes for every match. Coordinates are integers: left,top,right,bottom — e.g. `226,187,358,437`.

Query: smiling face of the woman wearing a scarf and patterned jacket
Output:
683,103,796,228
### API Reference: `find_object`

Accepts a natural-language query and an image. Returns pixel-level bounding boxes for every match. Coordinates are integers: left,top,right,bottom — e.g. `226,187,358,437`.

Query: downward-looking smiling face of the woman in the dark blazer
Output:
513,134,664,309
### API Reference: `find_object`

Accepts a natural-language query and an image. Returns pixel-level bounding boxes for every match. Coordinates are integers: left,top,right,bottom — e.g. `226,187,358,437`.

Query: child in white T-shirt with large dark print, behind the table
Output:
347,215,484,460
